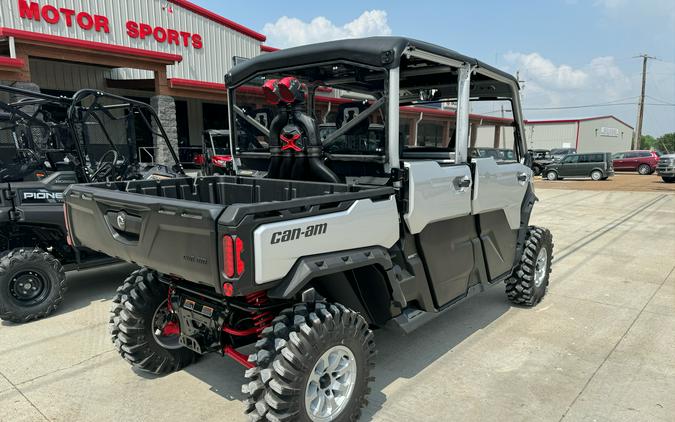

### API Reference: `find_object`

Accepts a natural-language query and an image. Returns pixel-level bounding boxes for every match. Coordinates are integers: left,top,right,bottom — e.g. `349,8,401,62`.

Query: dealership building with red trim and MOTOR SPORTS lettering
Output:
0,0,273,161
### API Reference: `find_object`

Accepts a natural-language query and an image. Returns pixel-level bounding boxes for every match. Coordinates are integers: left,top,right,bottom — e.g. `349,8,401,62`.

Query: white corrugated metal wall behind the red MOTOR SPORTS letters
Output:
0,0,261,83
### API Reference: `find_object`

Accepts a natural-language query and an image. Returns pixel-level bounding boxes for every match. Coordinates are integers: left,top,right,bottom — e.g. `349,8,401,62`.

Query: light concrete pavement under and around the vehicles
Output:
0,189,675,422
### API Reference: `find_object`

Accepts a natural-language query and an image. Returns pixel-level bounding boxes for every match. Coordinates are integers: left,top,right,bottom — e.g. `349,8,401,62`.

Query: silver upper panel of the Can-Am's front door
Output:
471,158,532,230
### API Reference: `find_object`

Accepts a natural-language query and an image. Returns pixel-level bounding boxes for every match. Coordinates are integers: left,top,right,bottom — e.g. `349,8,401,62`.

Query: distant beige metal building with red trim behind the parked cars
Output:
525,116,633,152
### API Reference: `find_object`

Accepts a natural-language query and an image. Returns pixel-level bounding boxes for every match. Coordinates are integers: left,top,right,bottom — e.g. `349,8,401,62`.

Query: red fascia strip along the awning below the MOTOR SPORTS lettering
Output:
0,27,183,63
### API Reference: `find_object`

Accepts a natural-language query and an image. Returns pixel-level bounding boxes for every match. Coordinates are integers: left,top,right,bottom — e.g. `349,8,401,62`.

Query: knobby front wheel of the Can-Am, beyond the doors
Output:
506,226,553,306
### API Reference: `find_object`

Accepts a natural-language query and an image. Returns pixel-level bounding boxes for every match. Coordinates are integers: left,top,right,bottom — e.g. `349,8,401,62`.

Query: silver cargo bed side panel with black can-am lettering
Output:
253,196,399,284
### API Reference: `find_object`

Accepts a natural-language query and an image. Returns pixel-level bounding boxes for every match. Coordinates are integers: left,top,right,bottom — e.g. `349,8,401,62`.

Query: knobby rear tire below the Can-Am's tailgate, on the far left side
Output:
110,268,196,375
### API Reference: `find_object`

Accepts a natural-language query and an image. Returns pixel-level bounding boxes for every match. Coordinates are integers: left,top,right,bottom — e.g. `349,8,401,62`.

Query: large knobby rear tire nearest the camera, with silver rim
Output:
242,303,376,422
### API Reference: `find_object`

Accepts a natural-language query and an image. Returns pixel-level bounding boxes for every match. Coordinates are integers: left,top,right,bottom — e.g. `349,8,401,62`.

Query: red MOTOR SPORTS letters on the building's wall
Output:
17,0,204,49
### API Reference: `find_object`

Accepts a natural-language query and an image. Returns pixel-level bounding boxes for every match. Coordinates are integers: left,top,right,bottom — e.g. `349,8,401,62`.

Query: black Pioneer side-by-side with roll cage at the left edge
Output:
0,86,182,322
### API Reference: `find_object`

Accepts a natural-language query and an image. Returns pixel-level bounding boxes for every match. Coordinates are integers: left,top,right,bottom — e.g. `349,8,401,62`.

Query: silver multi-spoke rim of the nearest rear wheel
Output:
305,345,357,422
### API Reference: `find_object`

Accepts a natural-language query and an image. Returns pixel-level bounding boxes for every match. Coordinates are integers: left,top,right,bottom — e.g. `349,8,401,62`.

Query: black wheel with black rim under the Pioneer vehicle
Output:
0,248,67,323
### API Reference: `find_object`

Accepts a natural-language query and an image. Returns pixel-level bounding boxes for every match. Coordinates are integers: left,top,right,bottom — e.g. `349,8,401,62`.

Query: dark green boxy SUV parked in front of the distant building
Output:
542,152,614,180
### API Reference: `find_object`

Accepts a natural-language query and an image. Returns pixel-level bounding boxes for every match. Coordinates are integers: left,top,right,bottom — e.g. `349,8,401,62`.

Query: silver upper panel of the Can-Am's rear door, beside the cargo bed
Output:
403,161,471,234
